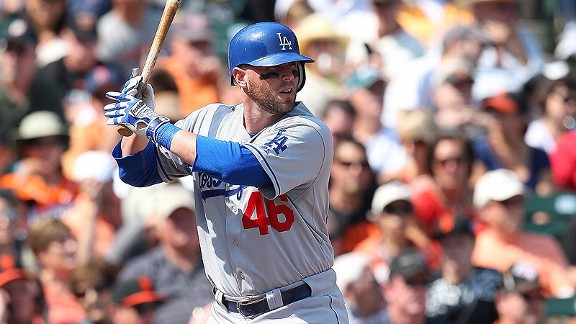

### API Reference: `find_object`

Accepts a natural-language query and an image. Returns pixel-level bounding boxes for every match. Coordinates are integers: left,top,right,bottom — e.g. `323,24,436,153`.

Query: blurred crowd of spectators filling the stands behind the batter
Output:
0,0,576,324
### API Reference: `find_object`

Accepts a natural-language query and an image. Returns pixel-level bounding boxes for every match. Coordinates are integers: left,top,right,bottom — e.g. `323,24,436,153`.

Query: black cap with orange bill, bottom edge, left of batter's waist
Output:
112,276,166,307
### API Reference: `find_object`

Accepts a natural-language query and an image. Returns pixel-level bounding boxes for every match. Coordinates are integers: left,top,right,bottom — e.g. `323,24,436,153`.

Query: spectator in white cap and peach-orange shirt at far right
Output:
472,169,575,298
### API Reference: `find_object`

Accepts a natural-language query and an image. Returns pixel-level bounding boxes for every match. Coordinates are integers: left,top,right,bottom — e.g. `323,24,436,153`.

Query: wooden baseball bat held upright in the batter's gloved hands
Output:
117,0,182,136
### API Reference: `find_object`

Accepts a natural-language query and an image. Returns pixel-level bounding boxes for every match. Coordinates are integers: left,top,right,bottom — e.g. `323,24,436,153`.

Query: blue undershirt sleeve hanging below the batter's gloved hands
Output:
112,142,162,187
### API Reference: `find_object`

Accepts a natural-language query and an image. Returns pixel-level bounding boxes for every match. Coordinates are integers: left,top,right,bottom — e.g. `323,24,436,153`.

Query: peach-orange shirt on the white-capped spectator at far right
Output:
472,228,574,298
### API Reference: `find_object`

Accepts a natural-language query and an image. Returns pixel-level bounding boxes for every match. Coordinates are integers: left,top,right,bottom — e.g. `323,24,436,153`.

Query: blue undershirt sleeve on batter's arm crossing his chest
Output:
192,136,272,187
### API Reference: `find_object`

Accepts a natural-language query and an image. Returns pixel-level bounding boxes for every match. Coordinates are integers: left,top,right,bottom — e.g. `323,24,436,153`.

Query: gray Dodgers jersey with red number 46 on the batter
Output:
158,103,342,314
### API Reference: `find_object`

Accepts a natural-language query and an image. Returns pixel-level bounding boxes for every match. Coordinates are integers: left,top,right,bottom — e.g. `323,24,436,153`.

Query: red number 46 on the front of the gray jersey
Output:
242,191,294,235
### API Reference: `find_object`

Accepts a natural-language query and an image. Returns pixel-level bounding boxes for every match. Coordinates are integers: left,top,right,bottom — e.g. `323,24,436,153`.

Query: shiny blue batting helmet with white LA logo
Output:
228,22,314,91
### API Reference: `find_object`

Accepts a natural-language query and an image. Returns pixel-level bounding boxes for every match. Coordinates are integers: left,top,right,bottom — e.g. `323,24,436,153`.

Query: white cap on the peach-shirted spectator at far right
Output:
473,169,526,208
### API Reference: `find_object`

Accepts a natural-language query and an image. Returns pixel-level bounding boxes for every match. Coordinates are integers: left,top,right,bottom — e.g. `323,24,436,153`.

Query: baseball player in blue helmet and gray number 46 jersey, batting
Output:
104,22,348,324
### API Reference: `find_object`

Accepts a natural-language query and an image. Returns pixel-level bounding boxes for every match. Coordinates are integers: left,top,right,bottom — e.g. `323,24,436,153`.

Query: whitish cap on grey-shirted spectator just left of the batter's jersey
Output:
145,183,196,222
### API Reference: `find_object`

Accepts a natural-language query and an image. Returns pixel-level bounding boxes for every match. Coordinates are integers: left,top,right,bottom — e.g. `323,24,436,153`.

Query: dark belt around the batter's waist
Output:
222,283,312,318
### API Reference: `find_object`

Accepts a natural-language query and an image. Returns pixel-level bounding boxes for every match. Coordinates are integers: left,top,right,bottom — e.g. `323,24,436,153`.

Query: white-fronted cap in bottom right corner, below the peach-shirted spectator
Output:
502,261,541,294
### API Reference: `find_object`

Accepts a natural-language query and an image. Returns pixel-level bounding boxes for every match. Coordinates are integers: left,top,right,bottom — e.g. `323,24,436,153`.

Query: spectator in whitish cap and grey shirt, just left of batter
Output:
119,182,214,323
